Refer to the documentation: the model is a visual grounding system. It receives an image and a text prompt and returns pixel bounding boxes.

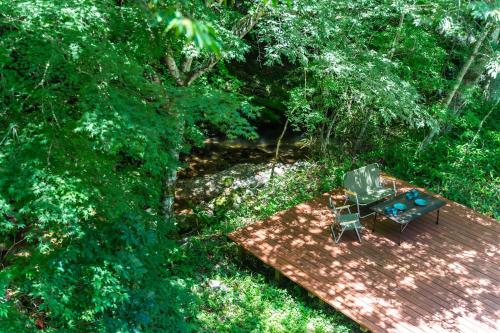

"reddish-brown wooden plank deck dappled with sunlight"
[229,178,500,333]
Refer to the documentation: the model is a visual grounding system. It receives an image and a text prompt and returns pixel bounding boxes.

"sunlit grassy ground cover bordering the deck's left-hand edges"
[170,160,360,333]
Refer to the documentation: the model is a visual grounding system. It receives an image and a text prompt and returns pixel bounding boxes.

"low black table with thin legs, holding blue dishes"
[370,191,446,245]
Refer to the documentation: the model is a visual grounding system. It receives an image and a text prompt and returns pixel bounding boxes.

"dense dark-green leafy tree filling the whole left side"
[0,0,256,332]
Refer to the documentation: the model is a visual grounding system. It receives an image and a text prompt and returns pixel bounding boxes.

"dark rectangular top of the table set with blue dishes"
[370,191,446,224]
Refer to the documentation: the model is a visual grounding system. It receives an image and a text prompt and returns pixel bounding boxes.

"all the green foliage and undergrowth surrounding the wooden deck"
[0,0,500,332]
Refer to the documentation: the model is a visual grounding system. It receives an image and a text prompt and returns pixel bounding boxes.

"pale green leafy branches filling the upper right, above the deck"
[257,0,496,153]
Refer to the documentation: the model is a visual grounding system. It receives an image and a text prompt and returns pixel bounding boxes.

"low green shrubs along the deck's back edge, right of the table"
[378,98,500,218]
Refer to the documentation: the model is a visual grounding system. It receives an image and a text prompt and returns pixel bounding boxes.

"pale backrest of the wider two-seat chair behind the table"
[344,163,380,193]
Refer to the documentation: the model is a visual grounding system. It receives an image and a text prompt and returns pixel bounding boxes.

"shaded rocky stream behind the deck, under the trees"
[174,128,307,213]
